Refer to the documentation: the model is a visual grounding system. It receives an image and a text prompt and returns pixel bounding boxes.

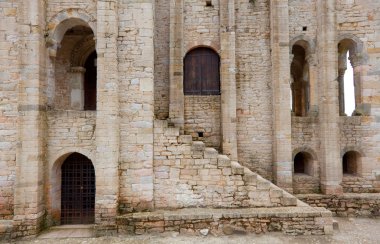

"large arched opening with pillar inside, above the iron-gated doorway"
[53,22,97,110]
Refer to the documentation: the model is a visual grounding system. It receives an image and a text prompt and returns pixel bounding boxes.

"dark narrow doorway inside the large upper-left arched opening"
[84,52,97,110]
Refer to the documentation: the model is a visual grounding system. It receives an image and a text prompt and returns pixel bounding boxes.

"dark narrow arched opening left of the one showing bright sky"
[291,44,310,116]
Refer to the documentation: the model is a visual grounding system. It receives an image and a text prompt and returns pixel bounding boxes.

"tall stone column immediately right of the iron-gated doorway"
[95,0,120,225]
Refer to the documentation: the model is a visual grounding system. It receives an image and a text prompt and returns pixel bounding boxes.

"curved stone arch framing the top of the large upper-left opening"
[46,9,96,57]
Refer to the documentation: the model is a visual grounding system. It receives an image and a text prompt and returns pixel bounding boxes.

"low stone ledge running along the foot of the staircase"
[116,207,333,235]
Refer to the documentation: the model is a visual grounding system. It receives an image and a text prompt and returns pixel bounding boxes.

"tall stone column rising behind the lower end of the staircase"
[270,0,293,192]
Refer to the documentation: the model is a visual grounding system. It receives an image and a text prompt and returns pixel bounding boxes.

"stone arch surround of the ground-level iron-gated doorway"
[49,149,97,225]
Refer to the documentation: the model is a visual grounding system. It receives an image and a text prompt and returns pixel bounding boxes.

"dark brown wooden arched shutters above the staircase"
[183,47,220,95]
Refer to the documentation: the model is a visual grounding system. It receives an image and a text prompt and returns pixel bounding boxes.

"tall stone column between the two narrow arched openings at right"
[317,0,343,194]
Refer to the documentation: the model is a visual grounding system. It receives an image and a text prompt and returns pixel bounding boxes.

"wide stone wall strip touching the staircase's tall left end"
[117,0,154,212]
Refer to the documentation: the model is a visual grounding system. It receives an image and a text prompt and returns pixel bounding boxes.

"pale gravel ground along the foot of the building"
[7,218,380,244]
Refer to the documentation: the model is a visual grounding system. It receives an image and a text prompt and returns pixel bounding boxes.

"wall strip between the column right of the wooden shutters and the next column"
[235,0,273,179]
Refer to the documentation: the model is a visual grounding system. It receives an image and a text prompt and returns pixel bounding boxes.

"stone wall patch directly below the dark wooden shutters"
[185,95,221,151]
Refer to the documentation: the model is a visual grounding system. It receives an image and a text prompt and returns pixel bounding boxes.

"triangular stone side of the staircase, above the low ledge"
[154,120,297,209]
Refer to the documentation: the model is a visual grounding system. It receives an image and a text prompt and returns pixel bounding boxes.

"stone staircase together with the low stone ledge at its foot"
[116,120,333,235]
